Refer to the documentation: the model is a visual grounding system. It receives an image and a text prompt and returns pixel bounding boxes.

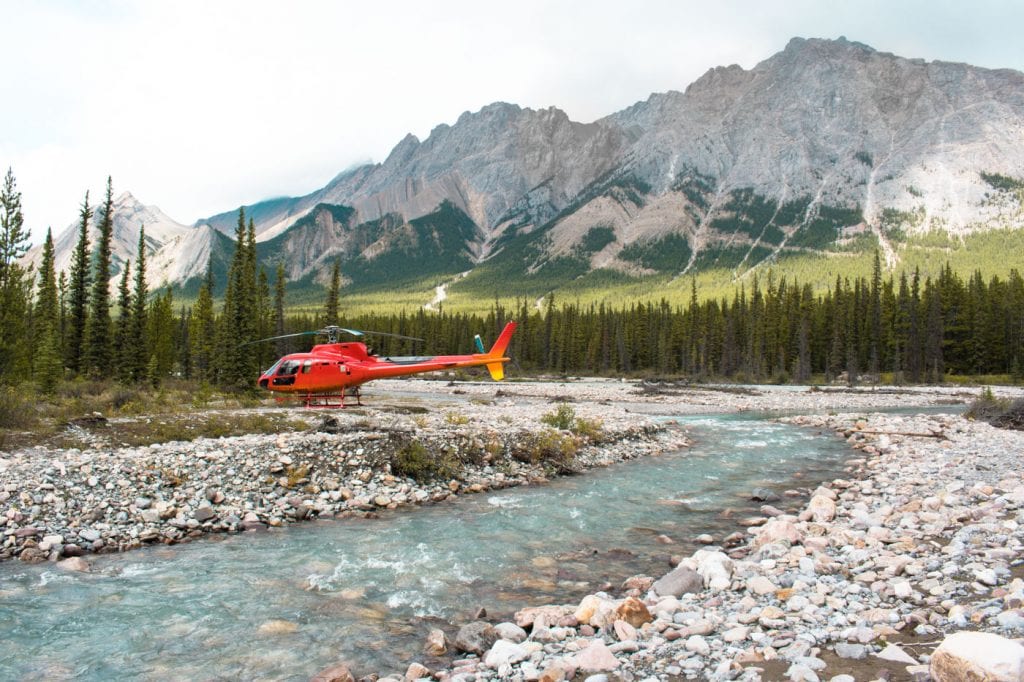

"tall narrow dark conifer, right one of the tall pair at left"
[83,176,114,376]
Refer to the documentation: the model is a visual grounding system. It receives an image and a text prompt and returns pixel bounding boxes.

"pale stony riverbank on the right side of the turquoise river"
[372,403,1024,682]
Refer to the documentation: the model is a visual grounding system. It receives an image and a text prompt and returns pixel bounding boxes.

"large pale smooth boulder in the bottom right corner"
[930,632,1024,682]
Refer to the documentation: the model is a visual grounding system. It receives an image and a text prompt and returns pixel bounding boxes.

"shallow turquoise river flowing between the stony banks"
[0,415,850,680]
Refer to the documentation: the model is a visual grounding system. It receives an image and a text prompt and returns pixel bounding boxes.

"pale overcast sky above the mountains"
[0,0,1024,242]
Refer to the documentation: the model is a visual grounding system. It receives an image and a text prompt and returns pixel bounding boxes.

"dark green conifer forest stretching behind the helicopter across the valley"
[0,170,1024,392]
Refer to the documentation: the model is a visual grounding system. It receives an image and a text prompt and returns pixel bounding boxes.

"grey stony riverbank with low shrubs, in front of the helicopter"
[0,399,683,569]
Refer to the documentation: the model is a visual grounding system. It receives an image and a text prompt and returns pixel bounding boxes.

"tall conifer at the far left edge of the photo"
[0,168,32,383]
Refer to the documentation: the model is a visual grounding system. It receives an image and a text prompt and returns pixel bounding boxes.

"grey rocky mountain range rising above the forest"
[24,38,1024,284]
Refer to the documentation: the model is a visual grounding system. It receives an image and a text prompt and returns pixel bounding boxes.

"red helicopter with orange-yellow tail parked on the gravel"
[257,322,516,408]
